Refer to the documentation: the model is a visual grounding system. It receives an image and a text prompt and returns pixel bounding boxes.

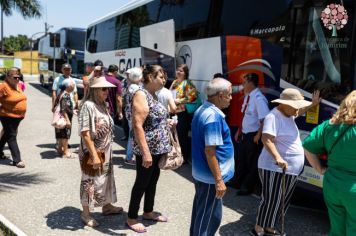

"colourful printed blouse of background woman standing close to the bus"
[172,79,198,113]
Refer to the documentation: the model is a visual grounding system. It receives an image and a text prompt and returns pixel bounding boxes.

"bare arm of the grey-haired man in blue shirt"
[205,146,226,199]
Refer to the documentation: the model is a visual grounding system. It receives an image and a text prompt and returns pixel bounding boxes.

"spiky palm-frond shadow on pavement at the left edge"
[0,171,50,192]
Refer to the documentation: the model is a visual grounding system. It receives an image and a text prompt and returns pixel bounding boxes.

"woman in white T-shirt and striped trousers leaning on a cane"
[250,88,320,235]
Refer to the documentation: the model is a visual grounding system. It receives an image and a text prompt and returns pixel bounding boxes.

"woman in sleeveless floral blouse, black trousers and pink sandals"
[126,65,171,233]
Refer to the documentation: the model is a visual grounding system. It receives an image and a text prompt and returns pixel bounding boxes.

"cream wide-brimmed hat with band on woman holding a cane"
[272,88,312,109]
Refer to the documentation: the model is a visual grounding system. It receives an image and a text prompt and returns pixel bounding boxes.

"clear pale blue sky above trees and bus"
[4,0,132,38]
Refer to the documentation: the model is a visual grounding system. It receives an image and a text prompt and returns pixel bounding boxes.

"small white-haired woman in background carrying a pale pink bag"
[52,78,75,158]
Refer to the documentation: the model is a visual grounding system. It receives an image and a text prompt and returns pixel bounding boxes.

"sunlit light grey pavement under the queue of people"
[0,81,328,236]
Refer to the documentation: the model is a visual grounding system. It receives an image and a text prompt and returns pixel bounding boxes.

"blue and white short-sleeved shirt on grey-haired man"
[192,101,235,184]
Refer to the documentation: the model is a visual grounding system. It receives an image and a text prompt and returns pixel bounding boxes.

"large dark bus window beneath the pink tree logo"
[282,4,353,104]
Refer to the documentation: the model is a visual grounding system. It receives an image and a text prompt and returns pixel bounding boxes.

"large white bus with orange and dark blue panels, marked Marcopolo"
[85,0,356,198]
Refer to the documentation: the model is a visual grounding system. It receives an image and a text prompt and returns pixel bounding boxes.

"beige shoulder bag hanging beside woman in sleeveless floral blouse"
[158,127,183,170]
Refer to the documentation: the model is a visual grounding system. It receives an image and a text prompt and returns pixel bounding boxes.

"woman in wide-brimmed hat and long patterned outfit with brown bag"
[79,76,123,227]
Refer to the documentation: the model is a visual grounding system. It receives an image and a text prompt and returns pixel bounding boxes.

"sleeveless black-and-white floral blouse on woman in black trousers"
[133,88,172,156]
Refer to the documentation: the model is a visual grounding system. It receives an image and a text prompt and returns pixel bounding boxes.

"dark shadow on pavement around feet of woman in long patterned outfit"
[46,206,127,235]
